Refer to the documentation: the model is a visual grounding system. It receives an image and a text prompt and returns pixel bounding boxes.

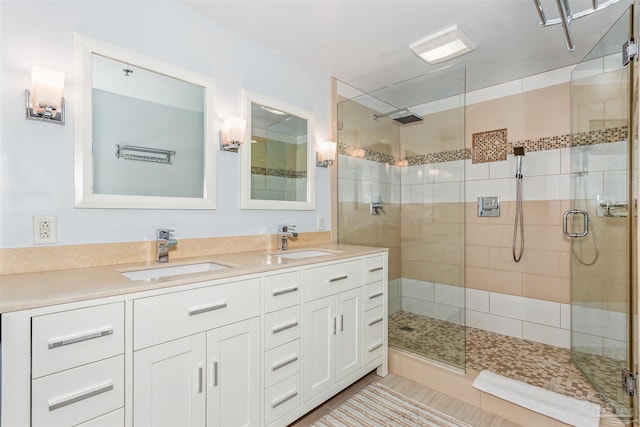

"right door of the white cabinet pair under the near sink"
[207,318,261,427]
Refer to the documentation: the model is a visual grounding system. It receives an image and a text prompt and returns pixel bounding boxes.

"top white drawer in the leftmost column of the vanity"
[31,303,124,378]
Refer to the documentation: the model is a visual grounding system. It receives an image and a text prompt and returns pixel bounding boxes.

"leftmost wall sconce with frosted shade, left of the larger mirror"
[25,67,65,125]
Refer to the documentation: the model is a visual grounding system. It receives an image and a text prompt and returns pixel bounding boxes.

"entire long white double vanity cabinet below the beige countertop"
[0,247,387,427]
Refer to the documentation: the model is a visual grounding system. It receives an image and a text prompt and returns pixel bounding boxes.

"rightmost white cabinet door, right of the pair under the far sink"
[335,288,362,381]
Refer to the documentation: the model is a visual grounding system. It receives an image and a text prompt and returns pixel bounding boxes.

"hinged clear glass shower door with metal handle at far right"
[564,5,637,422]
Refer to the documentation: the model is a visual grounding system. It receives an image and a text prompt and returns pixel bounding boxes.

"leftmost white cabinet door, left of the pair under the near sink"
[133,333,206,427]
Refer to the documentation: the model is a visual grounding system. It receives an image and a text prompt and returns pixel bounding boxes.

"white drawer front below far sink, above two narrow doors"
[304,260,362,302]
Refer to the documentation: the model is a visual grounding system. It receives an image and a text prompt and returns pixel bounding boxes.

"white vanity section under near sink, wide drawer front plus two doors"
[133,279,261,427]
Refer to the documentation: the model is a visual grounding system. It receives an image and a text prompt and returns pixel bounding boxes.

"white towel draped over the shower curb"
[473,370,600,427]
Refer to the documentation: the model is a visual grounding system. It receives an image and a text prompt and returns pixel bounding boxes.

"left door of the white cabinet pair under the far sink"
[302,297,337,401]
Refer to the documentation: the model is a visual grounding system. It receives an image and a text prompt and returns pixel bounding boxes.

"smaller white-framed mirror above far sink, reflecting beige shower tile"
[240,92,315,210]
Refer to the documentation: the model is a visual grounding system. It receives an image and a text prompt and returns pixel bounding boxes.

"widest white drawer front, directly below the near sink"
[133,279,260,350]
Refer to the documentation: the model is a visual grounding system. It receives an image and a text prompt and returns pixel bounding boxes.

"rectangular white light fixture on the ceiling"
[409,25,476,64]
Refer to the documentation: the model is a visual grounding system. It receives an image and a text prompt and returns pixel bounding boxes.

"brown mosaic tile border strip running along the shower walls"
[338,126,629,167]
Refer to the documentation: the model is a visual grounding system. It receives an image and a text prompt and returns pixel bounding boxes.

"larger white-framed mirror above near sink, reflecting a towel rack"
[74,34,217,209]
